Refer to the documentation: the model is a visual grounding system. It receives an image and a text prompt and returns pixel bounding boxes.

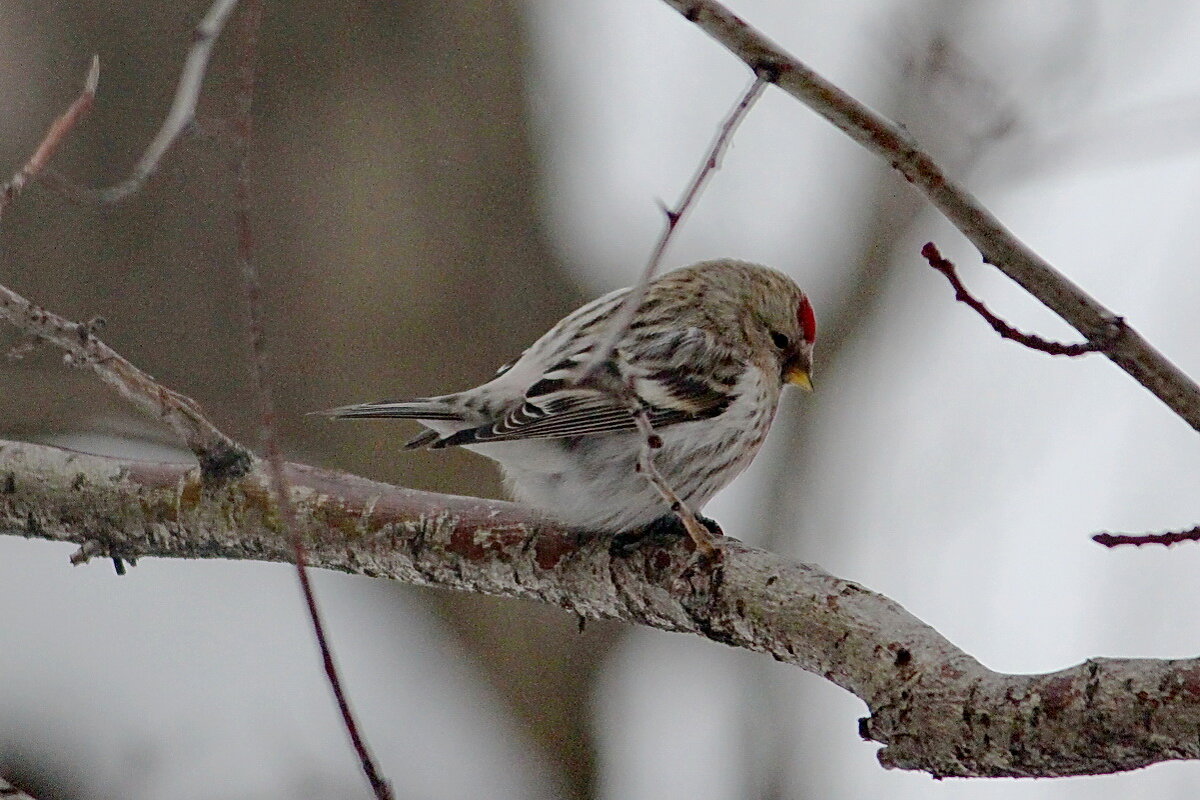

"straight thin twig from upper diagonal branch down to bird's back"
[580,74,769,380]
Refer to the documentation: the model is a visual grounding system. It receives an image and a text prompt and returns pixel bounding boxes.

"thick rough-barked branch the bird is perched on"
[0,441,1200,776]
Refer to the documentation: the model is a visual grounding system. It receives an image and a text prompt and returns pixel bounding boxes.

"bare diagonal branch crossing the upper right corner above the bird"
[664,0,1200,431]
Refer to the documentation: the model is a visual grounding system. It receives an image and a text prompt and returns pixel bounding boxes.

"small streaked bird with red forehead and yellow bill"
[326,259,816,544]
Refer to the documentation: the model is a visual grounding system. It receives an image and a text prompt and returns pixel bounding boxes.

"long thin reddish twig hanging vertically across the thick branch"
[226,0,394,800]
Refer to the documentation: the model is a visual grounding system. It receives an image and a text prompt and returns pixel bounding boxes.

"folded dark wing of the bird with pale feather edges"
[430,329,736,447]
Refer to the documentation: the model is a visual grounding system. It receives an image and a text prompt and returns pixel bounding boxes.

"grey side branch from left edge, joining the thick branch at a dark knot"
[0,285,252,480]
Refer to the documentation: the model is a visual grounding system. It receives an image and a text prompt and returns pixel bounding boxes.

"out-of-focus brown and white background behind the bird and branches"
[0,0,1200,800]
